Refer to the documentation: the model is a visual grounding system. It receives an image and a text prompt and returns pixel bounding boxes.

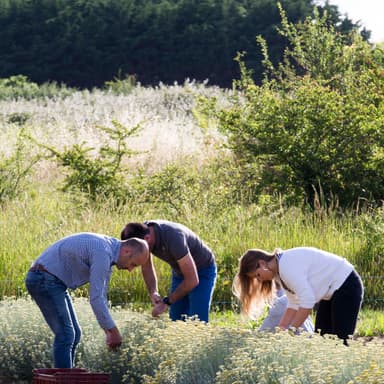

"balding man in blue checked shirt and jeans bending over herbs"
[25,232,149,368]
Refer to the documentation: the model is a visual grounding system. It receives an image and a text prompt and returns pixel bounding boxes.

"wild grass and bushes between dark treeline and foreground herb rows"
[0,5,384,305]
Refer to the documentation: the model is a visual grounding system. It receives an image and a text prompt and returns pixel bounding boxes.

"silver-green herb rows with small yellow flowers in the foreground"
[0,299,384,384]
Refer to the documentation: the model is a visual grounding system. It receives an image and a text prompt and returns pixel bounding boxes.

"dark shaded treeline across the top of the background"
[0,0,369,88]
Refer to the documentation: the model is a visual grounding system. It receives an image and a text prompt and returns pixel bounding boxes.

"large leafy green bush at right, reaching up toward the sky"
[206,4,384,207]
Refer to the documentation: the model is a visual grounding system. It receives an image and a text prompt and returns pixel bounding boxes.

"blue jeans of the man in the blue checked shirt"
[25,271,81,368]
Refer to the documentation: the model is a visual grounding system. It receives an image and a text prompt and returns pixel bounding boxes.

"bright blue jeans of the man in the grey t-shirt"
[169,265,217,322]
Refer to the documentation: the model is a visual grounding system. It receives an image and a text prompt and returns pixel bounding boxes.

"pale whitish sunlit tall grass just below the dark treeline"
[0,81,228,169]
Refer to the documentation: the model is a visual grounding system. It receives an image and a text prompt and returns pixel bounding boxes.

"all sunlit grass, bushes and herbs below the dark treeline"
[0,9,384,384]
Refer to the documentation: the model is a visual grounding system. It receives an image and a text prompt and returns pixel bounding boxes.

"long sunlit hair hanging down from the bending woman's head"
[232,249,278,319]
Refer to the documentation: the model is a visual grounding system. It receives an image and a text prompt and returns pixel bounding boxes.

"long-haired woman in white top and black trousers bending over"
[233,247,363,344]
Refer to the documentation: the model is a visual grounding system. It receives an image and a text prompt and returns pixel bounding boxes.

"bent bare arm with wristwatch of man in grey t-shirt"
[152,252,199,317]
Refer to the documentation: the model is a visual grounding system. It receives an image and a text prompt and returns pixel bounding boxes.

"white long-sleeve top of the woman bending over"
[278,247,354,309]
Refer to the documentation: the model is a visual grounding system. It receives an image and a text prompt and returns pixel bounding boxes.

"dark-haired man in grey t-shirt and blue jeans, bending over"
[121,220,217,322]
